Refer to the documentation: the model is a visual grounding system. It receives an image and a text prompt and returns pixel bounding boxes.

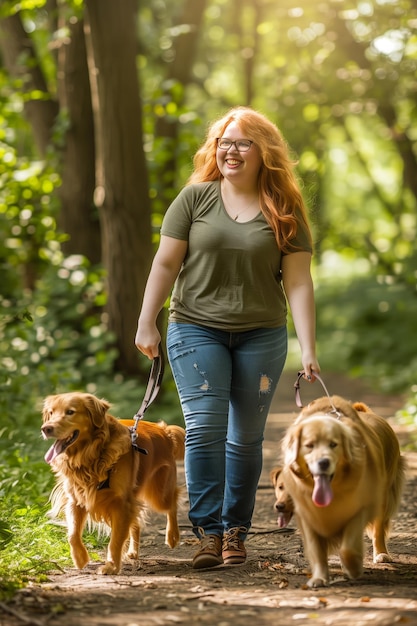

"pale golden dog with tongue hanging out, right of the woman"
[282,396,405,587]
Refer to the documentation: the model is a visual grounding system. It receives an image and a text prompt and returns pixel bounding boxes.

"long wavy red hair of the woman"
[187,107,311,252]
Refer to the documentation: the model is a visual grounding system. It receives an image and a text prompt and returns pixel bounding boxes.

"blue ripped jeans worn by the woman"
[167,322,287,539]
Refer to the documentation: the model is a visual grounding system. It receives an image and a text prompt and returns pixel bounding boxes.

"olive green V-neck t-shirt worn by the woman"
[161,181,311,332]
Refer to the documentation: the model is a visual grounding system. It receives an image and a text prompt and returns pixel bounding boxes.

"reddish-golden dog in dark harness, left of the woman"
[41,392,185,574]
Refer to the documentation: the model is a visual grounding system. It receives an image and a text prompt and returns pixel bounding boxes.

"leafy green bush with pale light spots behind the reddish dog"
[0,247,182,414]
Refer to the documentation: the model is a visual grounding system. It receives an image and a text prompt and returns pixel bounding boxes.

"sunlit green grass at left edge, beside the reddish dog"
[0,416,68,599]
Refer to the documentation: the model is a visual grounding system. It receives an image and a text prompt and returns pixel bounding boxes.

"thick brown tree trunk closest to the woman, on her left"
[85,0,153,374]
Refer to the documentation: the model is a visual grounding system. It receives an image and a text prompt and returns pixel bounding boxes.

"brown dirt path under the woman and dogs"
[0,375,417,626]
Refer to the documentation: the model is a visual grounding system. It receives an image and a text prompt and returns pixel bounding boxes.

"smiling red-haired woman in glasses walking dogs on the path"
[135,107,320,568]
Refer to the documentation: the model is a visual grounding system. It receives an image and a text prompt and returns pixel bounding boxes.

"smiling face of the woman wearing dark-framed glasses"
[216,122,262,188]
